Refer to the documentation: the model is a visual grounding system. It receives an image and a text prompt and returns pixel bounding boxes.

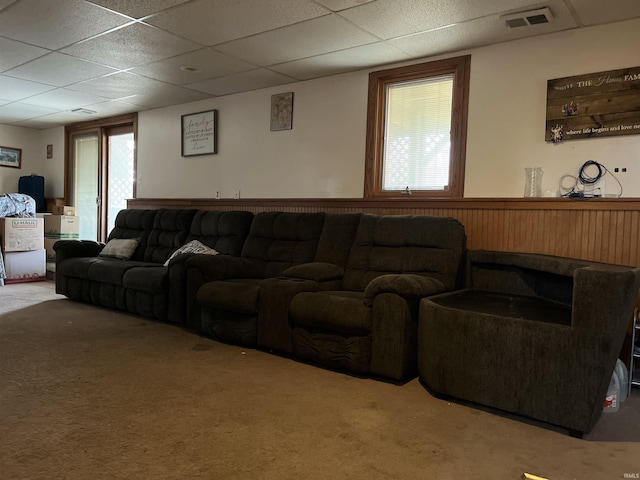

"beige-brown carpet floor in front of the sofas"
[0,282,640,480]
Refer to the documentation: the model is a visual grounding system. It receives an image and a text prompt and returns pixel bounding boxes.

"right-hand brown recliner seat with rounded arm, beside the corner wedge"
[290,214,465,381]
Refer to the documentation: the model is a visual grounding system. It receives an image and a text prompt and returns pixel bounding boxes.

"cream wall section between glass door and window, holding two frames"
[137,72,367,198]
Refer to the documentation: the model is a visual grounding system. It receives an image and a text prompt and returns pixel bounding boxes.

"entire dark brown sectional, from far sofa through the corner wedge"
[54,209,640,434]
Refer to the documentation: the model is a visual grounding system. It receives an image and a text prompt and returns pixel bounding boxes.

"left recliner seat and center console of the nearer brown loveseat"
[187,212,360,353]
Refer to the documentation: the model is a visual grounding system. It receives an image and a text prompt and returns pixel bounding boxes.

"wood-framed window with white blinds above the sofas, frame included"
[364,55,471,200]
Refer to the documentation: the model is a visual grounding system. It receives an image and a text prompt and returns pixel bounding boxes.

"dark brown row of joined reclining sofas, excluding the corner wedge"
[55,209,465,380]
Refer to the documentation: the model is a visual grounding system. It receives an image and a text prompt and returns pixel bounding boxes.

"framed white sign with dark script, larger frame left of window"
[181,110,218,157]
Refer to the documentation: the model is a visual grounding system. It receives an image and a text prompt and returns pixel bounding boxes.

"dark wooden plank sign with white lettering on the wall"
[545,67,640,143]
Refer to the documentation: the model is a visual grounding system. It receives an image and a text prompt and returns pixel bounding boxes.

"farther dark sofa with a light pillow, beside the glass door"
[54,209,253,324]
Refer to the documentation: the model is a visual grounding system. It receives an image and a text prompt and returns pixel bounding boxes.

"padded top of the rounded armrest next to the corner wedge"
[364,273,447,305]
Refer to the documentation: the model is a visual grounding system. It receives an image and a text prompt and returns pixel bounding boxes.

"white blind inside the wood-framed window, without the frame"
[382,75,454,191]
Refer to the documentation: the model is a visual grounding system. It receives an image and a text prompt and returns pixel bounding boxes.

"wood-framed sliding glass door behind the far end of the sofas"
[65,114,136,241]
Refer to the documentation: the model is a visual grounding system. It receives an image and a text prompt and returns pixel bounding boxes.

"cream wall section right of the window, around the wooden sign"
[465,19,640,197]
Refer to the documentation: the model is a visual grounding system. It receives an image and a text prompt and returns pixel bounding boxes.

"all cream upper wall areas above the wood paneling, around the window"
[5,19,640,198]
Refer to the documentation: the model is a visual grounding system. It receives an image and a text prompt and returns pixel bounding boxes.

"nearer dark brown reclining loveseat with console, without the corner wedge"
[187,213,465,380]
